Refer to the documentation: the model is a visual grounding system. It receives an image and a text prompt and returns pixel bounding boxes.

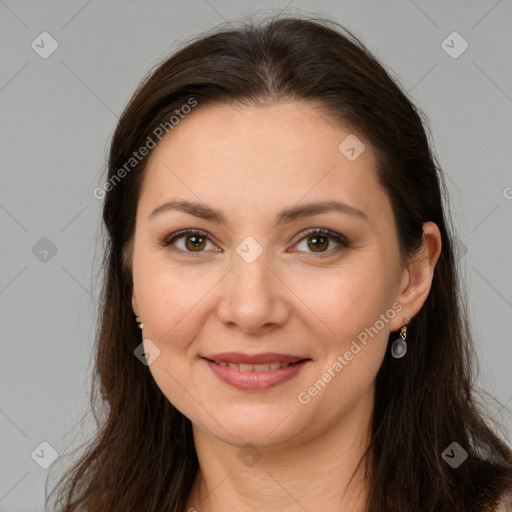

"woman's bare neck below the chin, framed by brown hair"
[185,388,373,512]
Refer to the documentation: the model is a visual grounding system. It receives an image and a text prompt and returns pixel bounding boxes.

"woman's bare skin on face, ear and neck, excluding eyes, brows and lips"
[131,101,441,512]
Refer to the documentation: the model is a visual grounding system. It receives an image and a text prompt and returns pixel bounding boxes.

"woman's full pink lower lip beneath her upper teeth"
[202,357,311,391]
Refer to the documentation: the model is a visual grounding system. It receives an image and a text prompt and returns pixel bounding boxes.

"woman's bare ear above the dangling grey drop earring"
[390,222,442,331]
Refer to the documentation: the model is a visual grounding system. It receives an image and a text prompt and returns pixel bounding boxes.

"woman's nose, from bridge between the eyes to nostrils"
[214,252,291,334]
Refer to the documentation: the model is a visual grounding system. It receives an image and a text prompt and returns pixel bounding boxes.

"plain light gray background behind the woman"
[0,0,512,512]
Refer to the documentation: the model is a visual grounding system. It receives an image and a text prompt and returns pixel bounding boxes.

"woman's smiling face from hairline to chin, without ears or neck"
[132,102,412,447]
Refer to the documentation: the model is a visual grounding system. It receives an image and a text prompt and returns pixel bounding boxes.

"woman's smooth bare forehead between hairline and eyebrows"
[141,101,387,224]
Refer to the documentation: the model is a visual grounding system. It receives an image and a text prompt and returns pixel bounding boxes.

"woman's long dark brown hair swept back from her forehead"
[47,16,512,512]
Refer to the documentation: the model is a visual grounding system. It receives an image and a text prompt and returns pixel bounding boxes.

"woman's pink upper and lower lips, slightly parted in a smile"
[202,353,311,391]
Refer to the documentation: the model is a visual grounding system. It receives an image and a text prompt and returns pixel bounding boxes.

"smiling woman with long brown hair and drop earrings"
[48,14,512,512]
